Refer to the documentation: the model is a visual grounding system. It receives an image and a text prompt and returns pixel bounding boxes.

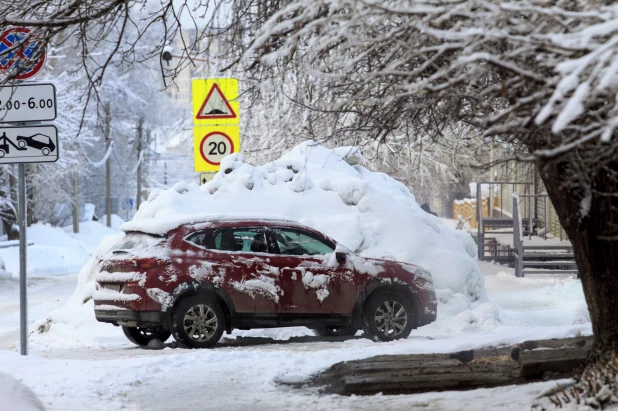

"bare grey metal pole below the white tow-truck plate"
[19,164,28,355]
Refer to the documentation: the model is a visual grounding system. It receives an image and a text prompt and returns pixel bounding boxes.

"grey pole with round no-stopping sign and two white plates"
[0,27,54,355]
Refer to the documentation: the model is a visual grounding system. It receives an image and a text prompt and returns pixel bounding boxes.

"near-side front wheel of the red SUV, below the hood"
[363,291,416,342]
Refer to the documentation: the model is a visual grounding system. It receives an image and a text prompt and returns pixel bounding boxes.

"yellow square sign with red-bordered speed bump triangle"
[191,78,240,126]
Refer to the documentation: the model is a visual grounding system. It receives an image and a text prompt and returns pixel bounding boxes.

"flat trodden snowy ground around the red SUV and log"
[0,264,591,410]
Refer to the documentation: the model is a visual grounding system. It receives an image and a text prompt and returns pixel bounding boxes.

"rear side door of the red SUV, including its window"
[183,227,281,316]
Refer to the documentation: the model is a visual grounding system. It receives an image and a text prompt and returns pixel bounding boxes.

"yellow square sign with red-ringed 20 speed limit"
[193,126,240,172]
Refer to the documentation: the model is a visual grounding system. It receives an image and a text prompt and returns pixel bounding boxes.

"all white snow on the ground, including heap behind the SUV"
[0,143,591,411]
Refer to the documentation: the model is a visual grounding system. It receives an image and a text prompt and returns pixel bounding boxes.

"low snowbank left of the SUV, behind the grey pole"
[0,221,117,278]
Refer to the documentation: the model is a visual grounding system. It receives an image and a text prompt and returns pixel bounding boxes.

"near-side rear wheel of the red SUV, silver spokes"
[171,295,225,348]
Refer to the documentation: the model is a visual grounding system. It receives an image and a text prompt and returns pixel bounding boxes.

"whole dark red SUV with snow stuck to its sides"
[93,218,437,348]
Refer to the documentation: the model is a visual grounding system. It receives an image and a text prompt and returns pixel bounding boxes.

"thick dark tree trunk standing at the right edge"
[539,153,618,355]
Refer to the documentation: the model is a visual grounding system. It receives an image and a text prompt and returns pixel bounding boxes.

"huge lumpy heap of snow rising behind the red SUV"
[121,141,486,302]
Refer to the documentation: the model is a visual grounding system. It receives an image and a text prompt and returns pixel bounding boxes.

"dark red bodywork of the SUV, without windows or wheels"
[93,219,437,331]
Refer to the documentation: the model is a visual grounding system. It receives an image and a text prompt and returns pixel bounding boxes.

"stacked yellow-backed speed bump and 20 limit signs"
[192,78,240,184]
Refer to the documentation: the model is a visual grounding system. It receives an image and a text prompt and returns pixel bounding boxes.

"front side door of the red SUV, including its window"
[268,227,356,315]
